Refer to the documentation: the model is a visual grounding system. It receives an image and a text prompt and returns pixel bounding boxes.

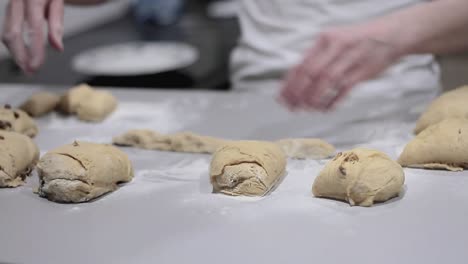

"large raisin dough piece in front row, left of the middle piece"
[37,142,133,203]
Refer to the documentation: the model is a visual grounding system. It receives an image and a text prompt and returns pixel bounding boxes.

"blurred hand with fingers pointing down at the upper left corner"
[2,0,64,73]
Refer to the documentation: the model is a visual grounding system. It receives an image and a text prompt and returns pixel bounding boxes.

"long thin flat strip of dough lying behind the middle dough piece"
[112,129,335,159]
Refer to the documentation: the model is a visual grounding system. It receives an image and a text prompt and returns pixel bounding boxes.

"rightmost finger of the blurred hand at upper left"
[47,0,63,51]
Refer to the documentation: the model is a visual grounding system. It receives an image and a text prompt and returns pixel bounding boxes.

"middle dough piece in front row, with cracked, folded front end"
[210,141,286,196]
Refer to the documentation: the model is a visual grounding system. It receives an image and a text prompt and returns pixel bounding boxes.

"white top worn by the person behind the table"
[231,0,440,101]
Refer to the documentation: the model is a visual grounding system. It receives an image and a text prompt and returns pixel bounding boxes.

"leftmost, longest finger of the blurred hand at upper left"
[2,0,28,71]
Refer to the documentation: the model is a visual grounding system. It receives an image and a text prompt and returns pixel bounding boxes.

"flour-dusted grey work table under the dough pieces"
[0,85,468,264]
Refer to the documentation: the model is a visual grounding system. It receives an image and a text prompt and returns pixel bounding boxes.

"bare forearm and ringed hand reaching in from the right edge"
[280,0,468,110]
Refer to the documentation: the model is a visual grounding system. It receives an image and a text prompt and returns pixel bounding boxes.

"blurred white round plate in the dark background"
[72,42,199,76]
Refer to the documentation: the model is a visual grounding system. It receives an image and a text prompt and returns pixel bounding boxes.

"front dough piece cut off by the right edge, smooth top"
[398,118,468,171]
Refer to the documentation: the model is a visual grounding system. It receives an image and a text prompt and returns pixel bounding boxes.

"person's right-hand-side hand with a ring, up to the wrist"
[280,26,402,111]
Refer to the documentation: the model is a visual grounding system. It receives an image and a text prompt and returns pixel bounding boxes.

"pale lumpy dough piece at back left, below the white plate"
[60,84,117,122]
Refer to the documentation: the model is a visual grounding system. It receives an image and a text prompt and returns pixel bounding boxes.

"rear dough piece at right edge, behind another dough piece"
[414,86,468,134]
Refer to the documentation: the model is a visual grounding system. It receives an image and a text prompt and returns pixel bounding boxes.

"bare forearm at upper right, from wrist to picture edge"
[375,0,468,54]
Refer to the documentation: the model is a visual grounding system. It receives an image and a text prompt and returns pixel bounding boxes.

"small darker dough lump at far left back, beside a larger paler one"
[19,92,60,117]
